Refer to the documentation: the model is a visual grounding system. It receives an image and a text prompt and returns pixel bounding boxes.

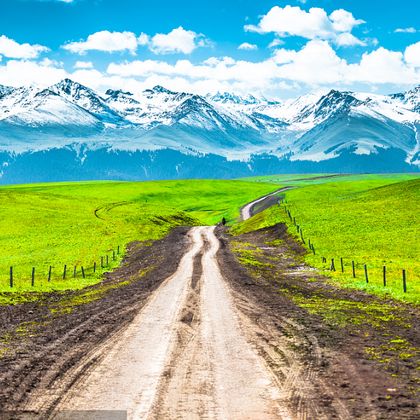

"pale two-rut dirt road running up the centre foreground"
[51,227,290,419]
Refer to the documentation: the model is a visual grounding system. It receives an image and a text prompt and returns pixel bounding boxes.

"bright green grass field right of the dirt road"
[233,174,420,303]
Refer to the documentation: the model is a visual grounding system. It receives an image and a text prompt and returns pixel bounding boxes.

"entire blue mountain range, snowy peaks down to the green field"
[0,79,420,183]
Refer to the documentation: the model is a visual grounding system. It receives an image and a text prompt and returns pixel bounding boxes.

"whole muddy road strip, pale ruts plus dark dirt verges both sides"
[0,223,420,420]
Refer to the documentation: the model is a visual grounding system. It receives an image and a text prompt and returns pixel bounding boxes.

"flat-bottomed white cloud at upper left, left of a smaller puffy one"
[63,31,138,54]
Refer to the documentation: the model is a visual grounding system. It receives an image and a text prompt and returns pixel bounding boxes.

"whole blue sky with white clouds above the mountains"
[0,0,420,98]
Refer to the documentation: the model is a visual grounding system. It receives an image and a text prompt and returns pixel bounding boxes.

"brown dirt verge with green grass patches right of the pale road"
[217,225,420,419]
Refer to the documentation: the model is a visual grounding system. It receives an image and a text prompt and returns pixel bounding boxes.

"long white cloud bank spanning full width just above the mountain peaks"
[0,39,420,96]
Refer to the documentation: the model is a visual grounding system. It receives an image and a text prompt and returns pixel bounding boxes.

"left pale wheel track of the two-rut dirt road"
[58,228,206,419]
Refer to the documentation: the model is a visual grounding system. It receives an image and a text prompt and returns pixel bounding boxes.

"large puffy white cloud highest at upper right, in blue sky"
[244,5,365,46]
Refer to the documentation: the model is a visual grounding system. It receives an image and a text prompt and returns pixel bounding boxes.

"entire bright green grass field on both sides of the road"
[0,174,420,303]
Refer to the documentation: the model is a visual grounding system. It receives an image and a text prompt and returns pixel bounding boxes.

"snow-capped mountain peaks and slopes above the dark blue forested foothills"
[0,79,420,183]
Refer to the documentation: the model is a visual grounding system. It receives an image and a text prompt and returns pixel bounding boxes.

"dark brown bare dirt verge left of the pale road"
[0,228,189,411]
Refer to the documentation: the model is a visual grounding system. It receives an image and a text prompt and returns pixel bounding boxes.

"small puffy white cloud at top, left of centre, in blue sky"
[149,26,206,54]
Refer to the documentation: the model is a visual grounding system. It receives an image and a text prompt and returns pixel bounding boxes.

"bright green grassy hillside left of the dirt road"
[0,180,276,301]
